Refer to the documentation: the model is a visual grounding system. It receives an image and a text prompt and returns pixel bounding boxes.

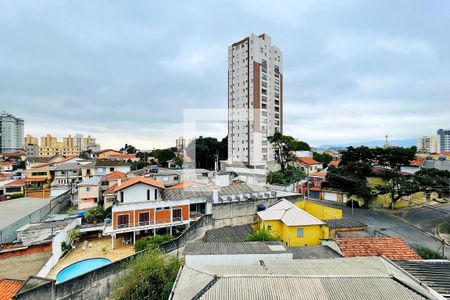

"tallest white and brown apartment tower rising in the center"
[228,34,283,166]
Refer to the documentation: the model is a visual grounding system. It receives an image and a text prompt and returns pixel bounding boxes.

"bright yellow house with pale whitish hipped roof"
[257,200,328,246]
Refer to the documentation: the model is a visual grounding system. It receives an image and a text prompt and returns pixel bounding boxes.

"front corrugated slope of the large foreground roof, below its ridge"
[199,276,426,300]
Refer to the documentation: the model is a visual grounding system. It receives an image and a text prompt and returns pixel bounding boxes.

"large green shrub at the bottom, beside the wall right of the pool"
[112,249,181,300]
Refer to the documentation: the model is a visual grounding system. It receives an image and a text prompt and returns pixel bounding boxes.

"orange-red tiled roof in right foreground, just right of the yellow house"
[336,237,421,260]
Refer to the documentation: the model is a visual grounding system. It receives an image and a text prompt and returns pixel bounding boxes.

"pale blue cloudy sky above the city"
[0,0,450,149]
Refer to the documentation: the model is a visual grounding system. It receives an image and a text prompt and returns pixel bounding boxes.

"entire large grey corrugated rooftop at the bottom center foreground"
[172,257,435,300]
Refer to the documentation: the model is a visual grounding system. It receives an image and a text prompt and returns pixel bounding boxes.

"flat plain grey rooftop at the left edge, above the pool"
[0,197,50,229]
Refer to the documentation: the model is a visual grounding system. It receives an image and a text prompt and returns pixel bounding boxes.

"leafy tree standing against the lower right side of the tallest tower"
[267,132,310,174]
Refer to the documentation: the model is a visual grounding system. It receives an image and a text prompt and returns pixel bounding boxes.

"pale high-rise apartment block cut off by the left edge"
[0,111,24,153]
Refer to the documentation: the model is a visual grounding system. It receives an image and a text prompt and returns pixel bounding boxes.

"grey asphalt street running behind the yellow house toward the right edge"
[310,200,450,256]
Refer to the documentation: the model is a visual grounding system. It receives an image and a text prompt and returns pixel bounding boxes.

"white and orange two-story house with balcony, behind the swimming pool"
[104,176,190,248]
